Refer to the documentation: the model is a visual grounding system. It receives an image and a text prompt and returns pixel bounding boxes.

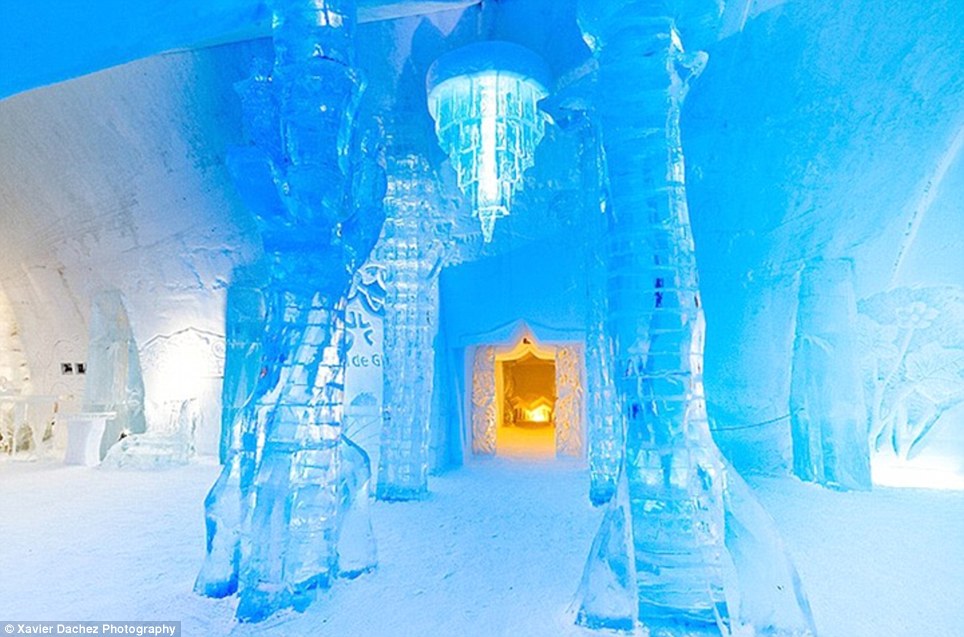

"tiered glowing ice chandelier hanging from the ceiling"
[426,41,549,242]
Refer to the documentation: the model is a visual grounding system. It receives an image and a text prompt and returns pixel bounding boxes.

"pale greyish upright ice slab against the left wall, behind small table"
[83,290,147,458]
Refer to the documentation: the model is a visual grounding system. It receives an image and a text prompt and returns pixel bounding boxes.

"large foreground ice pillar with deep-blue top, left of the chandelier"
[195,0,384,621]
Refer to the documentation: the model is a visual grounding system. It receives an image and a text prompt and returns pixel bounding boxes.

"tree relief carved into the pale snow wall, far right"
[858,286,964,459]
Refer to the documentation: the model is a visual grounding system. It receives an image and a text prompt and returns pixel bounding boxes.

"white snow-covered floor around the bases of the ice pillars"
[0,459,964,637]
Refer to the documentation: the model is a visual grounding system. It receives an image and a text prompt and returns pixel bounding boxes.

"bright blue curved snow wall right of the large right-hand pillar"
[683,0,964,471]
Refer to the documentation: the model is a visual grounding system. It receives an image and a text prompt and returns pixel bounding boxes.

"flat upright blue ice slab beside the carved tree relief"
[790,259,871,490]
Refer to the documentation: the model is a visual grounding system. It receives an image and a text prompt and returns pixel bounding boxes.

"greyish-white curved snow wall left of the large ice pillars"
[0,45,260,454]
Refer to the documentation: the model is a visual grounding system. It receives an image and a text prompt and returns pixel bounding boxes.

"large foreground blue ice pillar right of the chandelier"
[577,0,812,637]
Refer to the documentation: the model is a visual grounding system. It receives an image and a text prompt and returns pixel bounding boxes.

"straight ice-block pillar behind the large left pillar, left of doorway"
[375,144,443,500]
